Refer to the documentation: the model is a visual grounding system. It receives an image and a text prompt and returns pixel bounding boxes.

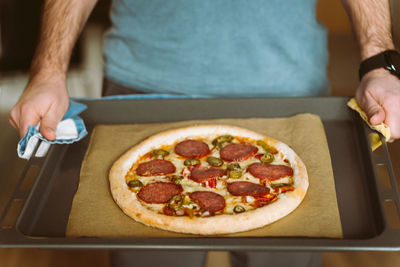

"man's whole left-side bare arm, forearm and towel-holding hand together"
[9,0,97,140]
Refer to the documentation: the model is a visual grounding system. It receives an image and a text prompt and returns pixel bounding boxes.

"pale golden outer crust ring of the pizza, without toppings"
[109,125,308,235]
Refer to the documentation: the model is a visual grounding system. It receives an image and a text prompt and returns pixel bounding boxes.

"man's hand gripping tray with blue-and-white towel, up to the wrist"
[9,76,69,140]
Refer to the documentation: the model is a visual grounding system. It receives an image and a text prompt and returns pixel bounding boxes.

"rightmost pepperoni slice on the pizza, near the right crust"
[247,162,293,180]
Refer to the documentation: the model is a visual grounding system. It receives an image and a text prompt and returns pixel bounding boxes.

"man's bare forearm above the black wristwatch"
[342,0,394,60]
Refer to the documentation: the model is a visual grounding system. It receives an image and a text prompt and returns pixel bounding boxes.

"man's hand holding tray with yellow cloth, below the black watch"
[356,69,400,141]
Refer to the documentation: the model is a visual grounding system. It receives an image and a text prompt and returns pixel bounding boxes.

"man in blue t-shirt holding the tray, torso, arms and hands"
[10,0,400,266]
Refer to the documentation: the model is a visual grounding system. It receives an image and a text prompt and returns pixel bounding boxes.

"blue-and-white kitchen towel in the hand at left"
[17,101,87,159]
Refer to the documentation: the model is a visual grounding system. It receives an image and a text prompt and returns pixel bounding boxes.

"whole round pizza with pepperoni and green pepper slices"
[109,125,308,235]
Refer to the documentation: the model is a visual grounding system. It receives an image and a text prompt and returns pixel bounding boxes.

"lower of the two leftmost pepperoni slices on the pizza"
[137,182,183,204]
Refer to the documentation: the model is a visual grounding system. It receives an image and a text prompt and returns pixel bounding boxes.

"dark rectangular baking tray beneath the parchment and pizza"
[0,97,400,251]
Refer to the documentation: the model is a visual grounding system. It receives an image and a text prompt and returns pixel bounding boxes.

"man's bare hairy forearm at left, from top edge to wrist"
[30,0,97,79]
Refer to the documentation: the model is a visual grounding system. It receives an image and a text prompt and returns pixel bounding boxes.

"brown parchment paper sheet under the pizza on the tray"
[66,114,342,238]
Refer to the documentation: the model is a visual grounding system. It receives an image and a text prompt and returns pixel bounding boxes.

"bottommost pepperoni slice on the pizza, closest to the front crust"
[190,191,225,212]
